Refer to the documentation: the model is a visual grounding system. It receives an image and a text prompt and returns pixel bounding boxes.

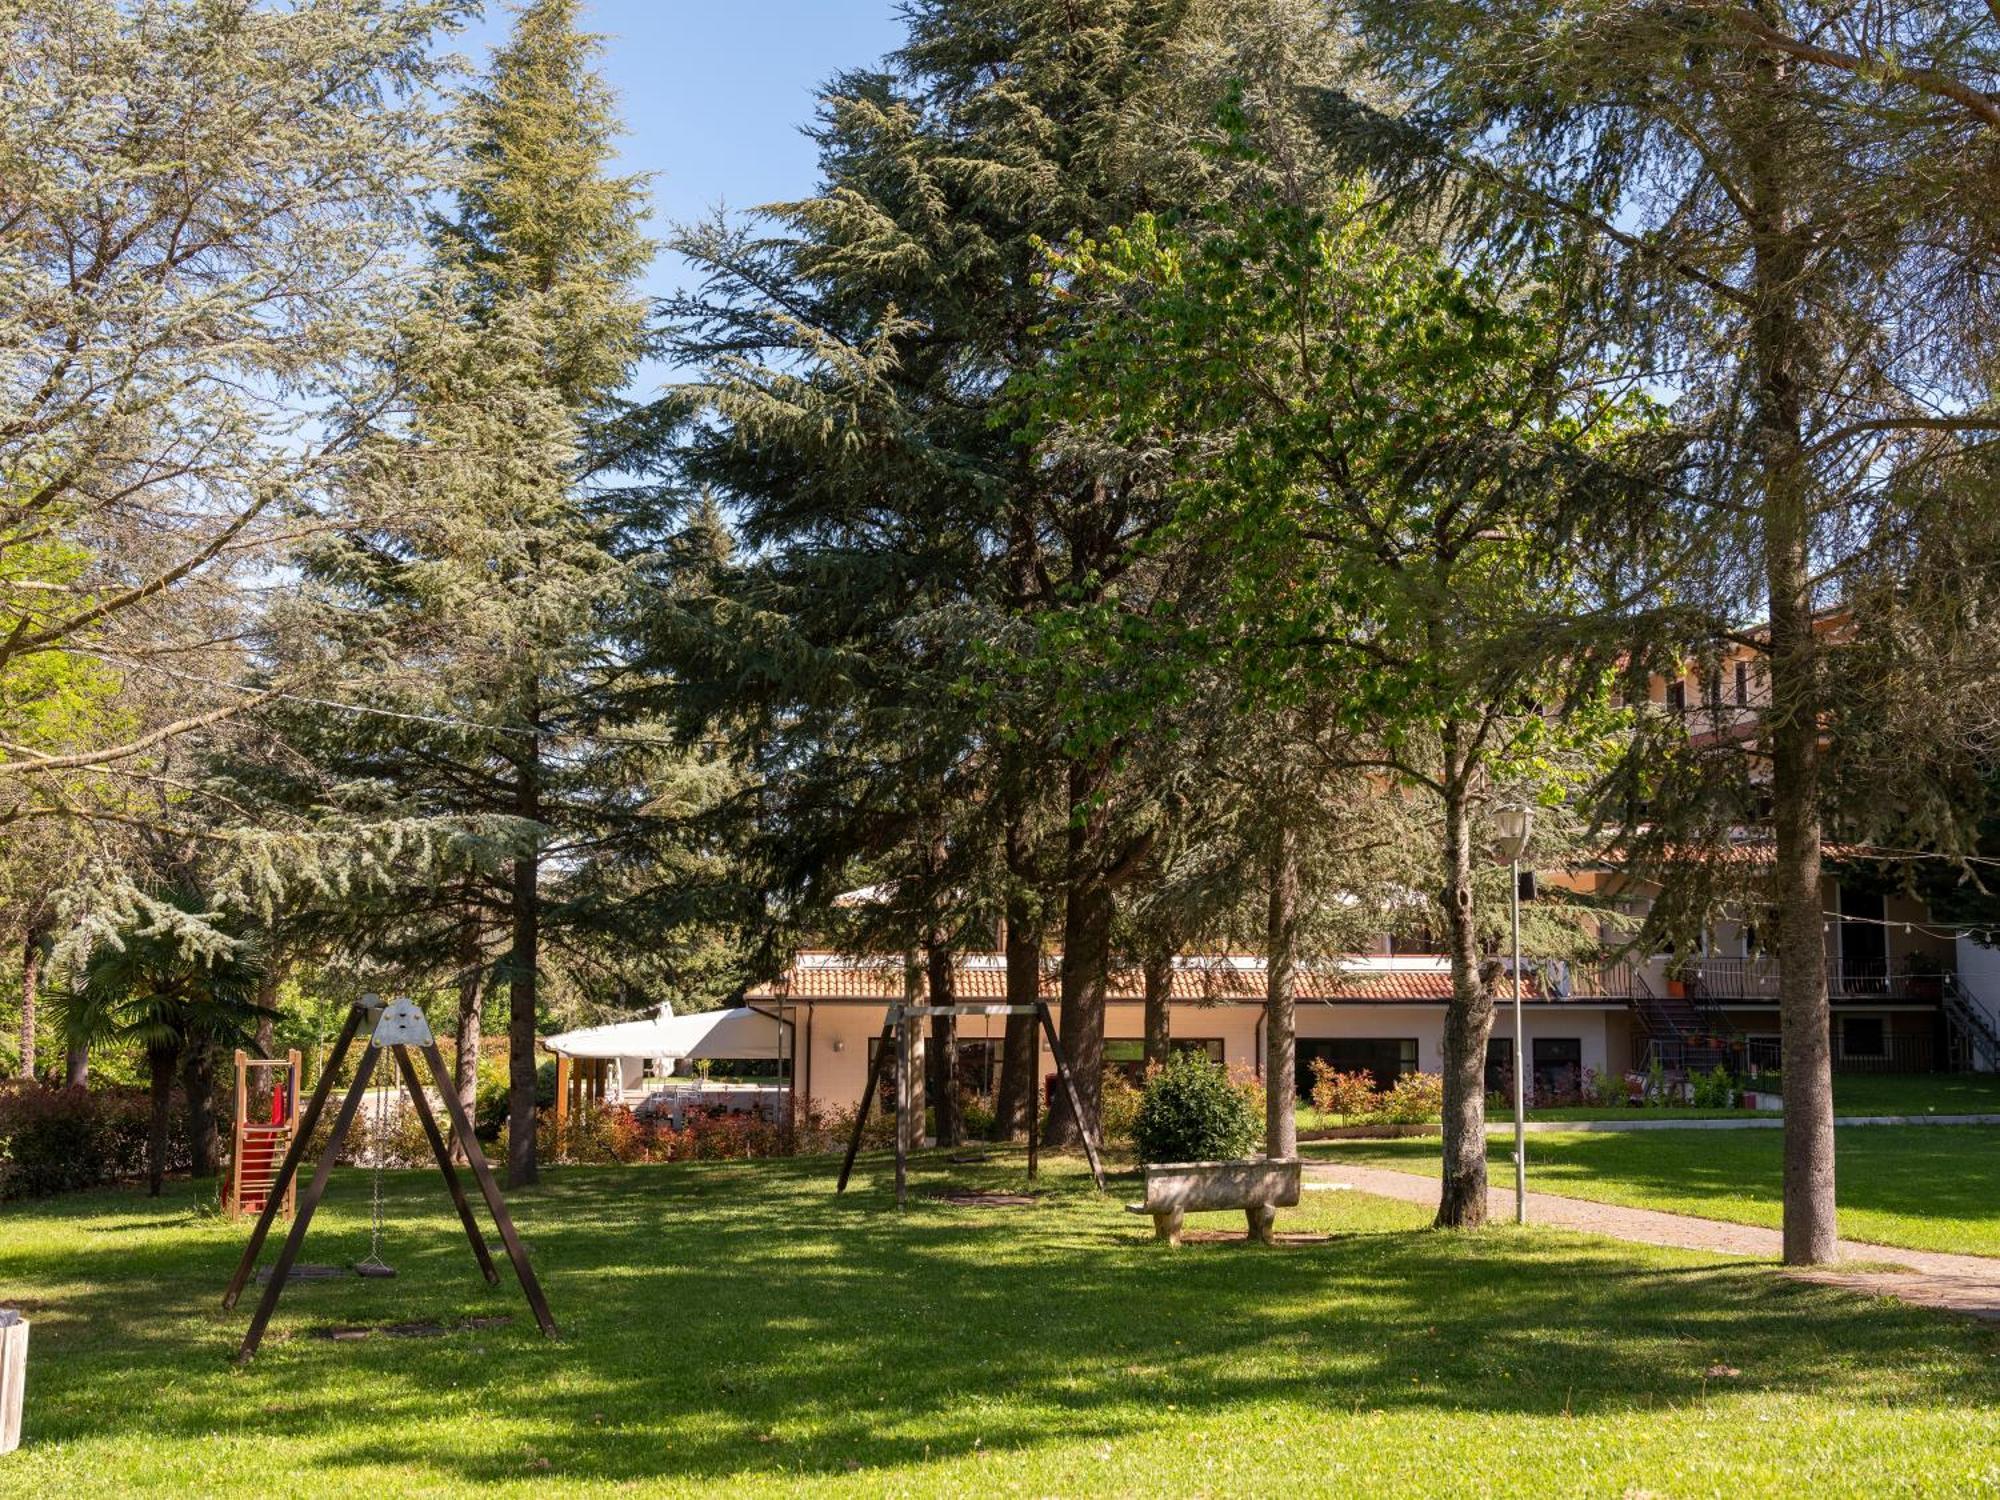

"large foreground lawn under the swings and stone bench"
[0,1160,2000,1496]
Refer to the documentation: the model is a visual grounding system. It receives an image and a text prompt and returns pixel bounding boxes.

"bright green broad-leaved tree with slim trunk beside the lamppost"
[1024,192,1676,1226]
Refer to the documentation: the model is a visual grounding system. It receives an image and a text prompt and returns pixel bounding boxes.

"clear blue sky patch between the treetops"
[458,0,902,312]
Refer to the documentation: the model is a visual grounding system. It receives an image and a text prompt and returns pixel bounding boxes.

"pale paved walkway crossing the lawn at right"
[1306,1162,2000,1322]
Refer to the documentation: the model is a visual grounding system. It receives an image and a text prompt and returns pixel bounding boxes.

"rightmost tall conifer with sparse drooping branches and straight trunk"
[1326,0,2000,1264]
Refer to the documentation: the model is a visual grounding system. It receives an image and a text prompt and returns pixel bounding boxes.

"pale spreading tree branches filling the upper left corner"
[0,0,466,848]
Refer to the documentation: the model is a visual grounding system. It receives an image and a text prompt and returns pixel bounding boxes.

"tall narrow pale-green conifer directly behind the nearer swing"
[254,0,662,1184]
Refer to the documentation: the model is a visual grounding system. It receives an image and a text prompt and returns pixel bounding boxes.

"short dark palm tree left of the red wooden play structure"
[56,888,274,1198]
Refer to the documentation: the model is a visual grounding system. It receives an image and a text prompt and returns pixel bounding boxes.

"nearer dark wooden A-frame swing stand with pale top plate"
[222,994,556,1362]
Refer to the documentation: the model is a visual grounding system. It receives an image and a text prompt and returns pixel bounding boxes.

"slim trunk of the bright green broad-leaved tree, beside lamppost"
[1436,776,1498,1230]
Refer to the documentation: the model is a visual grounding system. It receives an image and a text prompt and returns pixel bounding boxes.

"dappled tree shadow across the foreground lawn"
[0,1158,2000,1482]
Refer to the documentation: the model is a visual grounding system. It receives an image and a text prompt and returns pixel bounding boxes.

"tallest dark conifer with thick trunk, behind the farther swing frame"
[676,0,1332,1140]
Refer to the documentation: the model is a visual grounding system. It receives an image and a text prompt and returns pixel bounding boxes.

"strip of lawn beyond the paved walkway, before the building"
[1306,1126,2000,1256]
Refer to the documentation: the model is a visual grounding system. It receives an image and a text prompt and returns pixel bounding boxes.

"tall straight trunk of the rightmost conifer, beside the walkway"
[1738,26,1836,1266]
